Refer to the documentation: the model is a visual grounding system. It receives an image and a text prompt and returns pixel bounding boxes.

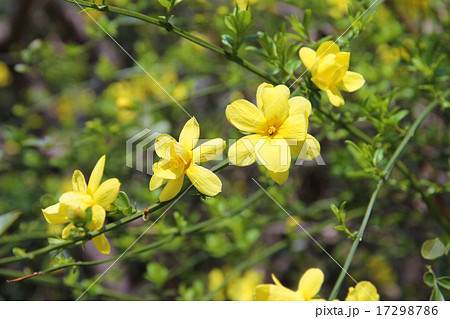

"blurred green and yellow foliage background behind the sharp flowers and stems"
[0,0,450,300]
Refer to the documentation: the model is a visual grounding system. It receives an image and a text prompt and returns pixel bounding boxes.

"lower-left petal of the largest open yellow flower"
[228,134,261,166]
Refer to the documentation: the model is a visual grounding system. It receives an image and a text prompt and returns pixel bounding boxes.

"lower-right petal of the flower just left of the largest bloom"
[186,165,222,196]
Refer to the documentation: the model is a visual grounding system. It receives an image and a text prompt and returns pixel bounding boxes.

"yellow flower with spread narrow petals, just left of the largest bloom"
[149,117,226,202]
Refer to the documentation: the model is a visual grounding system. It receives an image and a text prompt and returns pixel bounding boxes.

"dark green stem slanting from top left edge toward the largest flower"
[64,0,278,84]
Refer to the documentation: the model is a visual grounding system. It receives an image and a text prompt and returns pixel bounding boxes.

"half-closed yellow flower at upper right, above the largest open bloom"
[299,41,364,106]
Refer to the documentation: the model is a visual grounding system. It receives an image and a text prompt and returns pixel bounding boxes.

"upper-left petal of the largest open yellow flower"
[225,100,267,133]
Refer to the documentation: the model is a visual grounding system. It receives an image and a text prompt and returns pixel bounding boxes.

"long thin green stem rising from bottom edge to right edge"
[328,95,446,300]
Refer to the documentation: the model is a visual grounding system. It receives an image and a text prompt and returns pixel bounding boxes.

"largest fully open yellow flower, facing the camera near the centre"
[226,83,320,185]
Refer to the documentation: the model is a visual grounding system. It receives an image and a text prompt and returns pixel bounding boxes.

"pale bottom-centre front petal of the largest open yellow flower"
[255,138,291,173]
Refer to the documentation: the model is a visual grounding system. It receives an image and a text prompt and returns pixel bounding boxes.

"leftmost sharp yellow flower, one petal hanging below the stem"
[42,155,120,255]
